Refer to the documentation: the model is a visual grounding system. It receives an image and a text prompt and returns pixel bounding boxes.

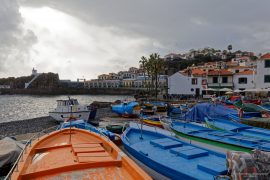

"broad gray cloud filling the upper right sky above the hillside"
[21,0,270,53]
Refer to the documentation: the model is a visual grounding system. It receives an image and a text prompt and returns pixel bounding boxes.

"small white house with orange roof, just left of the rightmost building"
[233,70,256,90]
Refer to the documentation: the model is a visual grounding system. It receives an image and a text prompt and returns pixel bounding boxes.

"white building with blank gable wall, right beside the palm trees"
[168,69,207,96]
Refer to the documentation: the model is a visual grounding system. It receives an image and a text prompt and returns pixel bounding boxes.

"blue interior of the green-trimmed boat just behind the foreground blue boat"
[171,122,270,151]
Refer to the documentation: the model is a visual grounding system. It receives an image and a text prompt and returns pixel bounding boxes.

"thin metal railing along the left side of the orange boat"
[5,125,58,180]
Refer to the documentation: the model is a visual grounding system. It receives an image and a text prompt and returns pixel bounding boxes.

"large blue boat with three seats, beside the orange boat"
[121,124,227,179]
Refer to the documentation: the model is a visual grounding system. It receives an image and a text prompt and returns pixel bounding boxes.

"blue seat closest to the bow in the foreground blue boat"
[150,138,183,149]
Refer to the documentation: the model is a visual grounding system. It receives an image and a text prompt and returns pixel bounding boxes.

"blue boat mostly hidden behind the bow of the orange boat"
[57,119,115,141]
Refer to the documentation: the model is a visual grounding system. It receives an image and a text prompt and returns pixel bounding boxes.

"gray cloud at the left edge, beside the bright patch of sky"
[0,0,37,76]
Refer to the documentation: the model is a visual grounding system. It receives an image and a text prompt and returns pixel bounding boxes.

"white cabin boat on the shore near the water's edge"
[49,98,90,122]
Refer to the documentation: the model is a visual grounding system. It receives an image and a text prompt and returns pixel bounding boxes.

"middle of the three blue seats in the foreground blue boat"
[170,146,208,159]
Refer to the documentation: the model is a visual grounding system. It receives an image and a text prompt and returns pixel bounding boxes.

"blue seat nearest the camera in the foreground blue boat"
[197,161,227,175]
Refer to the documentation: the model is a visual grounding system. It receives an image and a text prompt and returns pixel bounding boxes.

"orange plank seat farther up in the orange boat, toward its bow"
[72,143,105,155]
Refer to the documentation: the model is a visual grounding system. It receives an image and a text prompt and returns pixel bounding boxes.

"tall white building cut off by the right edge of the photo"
[255,53,270,88]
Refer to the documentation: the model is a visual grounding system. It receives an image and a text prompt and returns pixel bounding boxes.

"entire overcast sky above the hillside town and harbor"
[0,0,270,80]
